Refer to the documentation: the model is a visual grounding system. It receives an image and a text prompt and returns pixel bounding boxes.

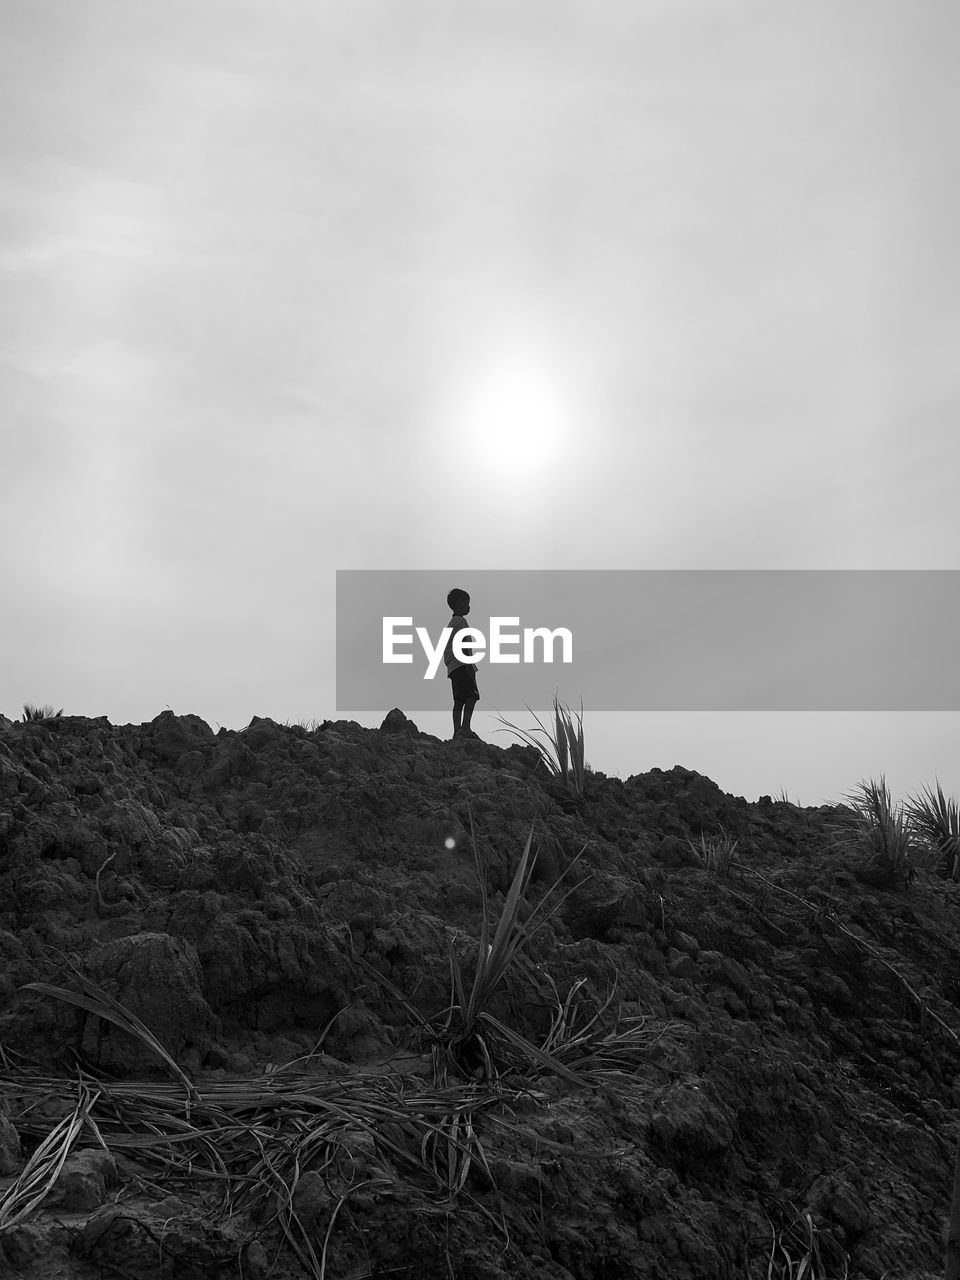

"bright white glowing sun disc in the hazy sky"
[463,358,568,479]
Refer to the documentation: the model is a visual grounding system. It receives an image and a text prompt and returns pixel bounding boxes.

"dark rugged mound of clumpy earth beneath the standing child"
[0,712,960,1280]
